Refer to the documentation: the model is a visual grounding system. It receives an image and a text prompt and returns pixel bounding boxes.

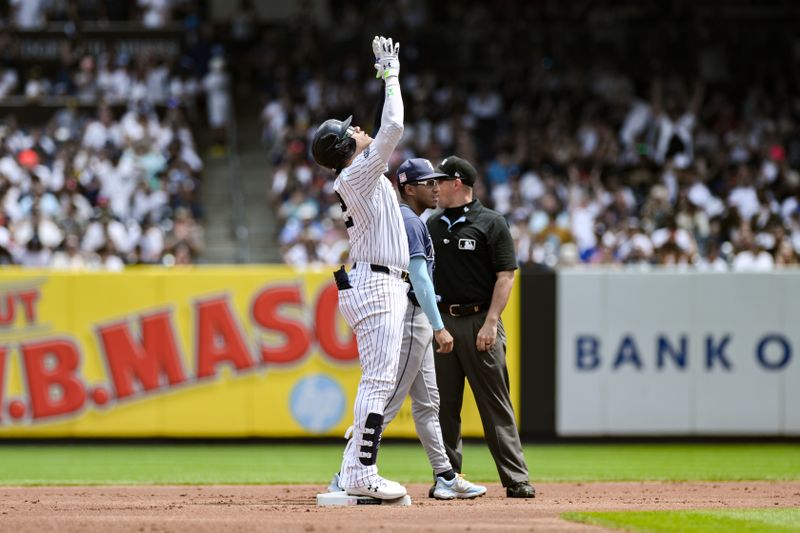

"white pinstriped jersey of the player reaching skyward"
[333,118,408,270]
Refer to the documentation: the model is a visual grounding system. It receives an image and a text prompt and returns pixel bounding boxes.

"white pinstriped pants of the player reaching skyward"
[339,265,408,489]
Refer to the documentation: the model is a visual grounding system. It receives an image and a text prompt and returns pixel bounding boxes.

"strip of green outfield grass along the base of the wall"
[0,441,800,485]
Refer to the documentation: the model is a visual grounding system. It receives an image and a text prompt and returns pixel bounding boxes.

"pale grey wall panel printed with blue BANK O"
[552,270,800,436]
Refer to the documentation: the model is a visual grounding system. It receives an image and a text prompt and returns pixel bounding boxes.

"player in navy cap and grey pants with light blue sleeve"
[328,159,486,500]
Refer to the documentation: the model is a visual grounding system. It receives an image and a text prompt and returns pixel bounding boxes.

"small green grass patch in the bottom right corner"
[561,509,800,533]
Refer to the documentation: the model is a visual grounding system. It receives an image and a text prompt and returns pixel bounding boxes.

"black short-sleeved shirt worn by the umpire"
[428,200,517,305]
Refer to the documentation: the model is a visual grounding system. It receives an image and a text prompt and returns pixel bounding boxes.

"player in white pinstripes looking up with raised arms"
[311,37,408,500]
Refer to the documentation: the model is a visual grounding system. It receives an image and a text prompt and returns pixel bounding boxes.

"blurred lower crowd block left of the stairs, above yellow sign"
[0,101,202,269]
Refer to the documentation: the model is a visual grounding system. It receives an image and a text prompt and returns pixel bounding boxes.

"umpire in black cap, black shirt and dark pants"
[428,156,536,498]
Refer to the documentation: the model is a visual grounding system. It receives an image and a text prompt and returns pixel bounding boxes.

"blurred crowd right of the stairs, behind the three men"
[262,0,800,271]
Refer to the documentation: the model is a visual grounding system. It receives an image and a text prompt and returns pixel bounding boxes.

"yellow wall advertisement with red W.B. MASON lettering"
[0,266,519,438]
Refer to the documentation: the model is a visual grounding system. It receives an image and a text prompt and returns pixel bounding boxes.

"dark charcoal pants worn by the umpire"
[434,311,528,487]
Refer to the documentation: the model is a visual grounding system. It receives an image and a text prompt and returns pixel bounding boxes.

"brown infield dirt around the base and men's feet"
[0,481,800,533]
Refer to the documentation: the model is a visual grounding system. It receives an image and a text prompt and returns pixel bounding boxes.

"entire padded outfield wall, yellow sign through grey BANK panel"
[0,266,800,438]
